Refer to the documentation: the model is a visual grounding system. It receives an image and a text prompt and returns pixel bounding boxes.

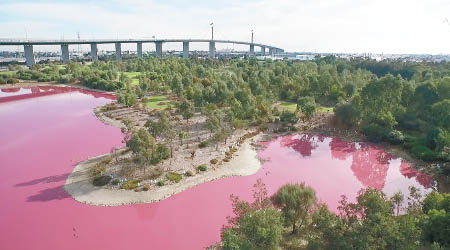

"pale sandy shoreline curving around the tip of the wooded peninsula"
[64,135,261,206]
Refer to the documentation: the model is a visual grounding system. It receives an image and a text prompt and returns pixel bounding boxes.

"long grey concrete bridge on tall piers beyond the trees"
[0,39,284,66]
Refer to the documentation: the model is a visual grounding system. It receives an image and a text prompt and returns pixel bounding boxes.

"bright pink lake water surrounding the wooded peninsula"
[0,87,432,250]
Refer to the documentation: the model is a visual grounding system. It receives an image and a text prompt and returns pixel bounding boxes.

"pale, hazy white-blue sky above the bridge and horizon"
[0,0,450,54]
